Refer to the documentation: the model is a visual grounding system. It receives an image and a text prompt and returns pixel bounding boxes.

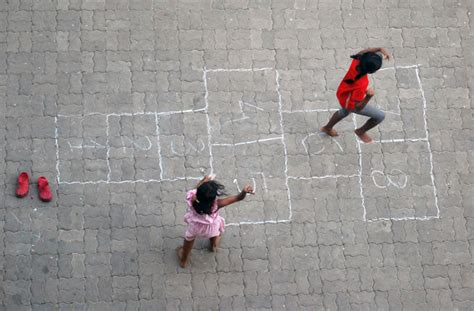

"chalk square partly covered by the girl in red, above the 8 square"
[356,67,426,141]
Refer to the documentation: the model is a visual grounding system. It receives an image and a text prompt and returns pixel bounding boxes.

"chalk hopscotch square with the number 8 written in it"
[361,142,439,221]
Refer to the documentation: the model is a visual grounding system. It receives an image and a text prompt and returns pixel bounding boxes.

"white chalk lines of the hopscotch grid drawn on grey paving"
[55,65,440,226]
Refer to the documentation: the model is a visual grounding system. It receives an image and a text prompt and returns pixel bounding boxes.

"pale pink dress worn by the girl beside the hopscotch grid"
[184,189,225,241]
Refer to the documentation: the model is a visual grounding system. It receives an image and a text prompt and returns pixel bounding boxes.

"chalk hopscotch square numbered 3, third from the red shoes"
[158,112,210,180]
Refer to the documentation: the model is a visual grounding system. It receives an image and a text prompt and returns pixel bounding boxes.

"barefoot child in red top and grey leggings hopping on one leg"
[321,48,390,143]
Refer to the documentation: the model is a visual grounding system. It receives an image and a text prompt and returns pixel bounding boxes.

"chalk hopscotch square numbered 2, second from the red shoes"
[108,113,160,182]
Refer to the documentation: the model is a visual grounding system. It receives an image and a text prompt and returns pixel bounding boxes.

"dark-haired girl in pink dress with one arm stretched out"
[178,176,253,268]
